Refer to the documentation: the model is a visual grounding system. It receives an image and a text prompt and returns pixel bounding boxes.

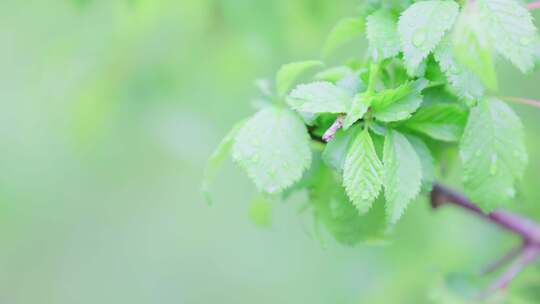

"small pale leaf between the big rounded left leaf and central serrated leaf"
[322,126,359,172]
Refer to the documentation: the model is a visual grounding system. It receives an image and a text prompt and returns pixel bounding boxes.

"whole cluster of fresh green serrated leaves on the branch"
[204,0,540,244]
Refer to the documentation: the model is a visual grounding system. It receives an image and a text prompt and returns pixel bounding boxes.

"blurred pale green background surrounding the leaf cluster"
[0,0,540,304]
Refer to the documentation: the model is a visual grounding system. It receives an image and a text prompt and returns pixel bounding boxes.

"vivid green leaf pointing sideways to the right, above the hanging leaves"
[404,103,467,142]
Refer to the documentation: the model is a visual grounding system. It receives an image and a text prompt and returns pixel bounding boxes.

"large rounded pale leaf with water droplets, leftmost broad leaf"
[232,107,311,193]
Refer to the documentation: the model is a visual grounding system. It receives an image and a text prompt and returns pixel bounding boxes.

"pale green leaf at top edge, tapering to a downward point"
[398,0,459,73]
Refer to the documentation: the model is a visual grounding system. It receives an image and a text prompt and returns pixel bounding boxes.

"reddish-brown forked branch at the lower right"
[431,184,540,297]
